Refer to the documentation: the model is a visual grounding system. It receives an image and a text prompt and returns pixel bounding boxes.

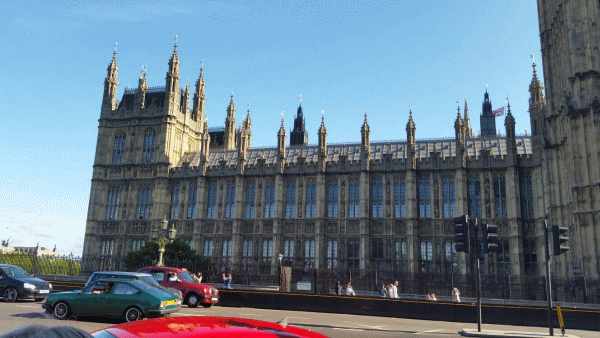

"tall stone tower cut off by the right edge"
[530,0,600,278]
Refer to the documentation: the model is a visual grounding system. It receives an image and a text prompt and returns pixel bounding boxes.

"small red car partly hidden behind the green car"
[138,266,219,308]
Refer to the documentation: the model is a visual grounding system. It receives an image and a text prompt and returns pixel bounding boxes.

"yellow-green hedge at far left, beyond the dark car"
[0,252,81,276]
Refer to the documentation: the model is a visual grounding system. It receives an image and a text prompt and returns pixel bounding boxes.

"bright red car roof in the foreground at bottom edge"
[91,316,326,338]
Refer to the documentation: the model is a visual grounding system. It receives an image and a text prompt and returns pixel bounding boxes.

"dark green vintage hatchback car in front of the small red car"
[42,278,181,322]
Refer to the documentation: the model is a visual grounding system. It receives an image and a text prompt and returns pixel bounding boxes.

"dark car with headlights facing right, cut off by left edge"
[0,264,52,302]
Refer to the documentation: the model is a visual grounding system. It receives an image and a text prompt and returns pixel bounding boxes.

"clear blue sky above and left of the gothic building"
[0,0,542,254]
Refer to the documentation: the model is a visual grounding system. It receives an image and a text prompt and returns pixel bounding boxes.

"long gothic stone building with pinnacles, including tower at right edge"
[84,0,600,278]
